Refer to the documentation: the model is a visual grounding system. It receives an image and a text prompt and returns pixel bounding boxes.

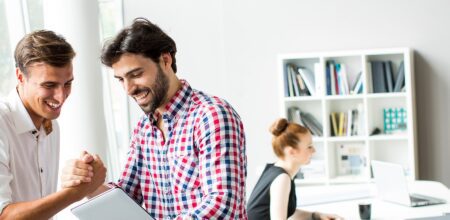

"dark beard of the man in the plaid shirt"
[134,66,169,114]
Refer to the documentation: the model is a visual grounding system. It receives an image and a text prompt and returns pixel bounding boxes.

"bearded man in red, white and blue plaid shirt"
[62,18,247,219]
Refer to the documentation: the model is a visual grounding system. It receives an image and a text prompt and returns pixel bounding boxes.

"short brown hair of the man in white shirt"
[14,30,75,74]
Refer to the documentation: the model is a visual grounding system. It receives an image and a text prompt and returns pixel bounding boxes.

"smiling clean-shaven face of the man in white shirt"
[16,62,73,128]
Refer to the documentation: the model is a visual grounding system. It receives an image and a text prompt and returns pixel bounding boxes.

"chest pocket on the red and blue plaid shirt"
[170,154,201,194]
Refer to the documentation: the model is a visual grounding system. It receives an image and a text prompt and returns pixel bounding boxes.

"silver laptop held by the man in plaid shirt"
[71,188,153,220]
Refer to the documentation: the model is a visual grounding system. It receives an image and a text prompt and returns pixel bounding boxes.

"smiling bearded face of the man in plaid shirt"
[112,53,169,114]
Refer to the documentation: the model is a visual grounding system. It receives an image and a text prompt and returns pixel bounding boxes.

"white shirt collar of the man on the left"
[8,89,53,135]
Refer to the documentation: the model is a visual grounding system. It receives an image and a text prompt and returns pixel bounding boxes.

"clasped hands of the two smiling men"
[61,151,106,199]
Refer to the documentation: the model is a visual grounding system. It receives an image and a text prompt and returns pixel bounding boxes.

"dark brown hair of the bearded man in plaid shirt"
[101,18,177,72]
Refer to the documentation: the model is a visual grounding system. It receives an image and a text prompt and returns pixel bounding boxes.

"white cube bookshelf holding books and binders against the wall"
[278,48,418,185]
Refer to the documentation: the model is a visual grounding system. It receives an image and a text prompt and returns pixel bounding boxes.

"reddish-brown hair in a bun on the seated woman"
[270,118,309,157]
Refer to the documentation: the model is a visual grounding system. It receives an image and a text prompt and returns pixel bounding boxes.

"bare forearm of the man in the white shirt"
[0,189,83,220]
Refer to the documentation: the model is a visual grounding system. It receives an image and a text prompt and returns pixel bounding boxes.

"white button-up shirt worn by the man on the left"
[0,90,60,213]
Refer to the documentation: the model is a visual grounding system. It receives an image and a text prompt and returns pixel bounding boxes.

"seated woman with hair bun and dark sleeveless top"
[247,118,341,220]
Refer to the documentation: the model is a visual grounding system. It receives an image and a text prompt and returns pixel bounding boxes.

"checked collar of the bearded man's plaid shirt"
[149,80,192,121]
